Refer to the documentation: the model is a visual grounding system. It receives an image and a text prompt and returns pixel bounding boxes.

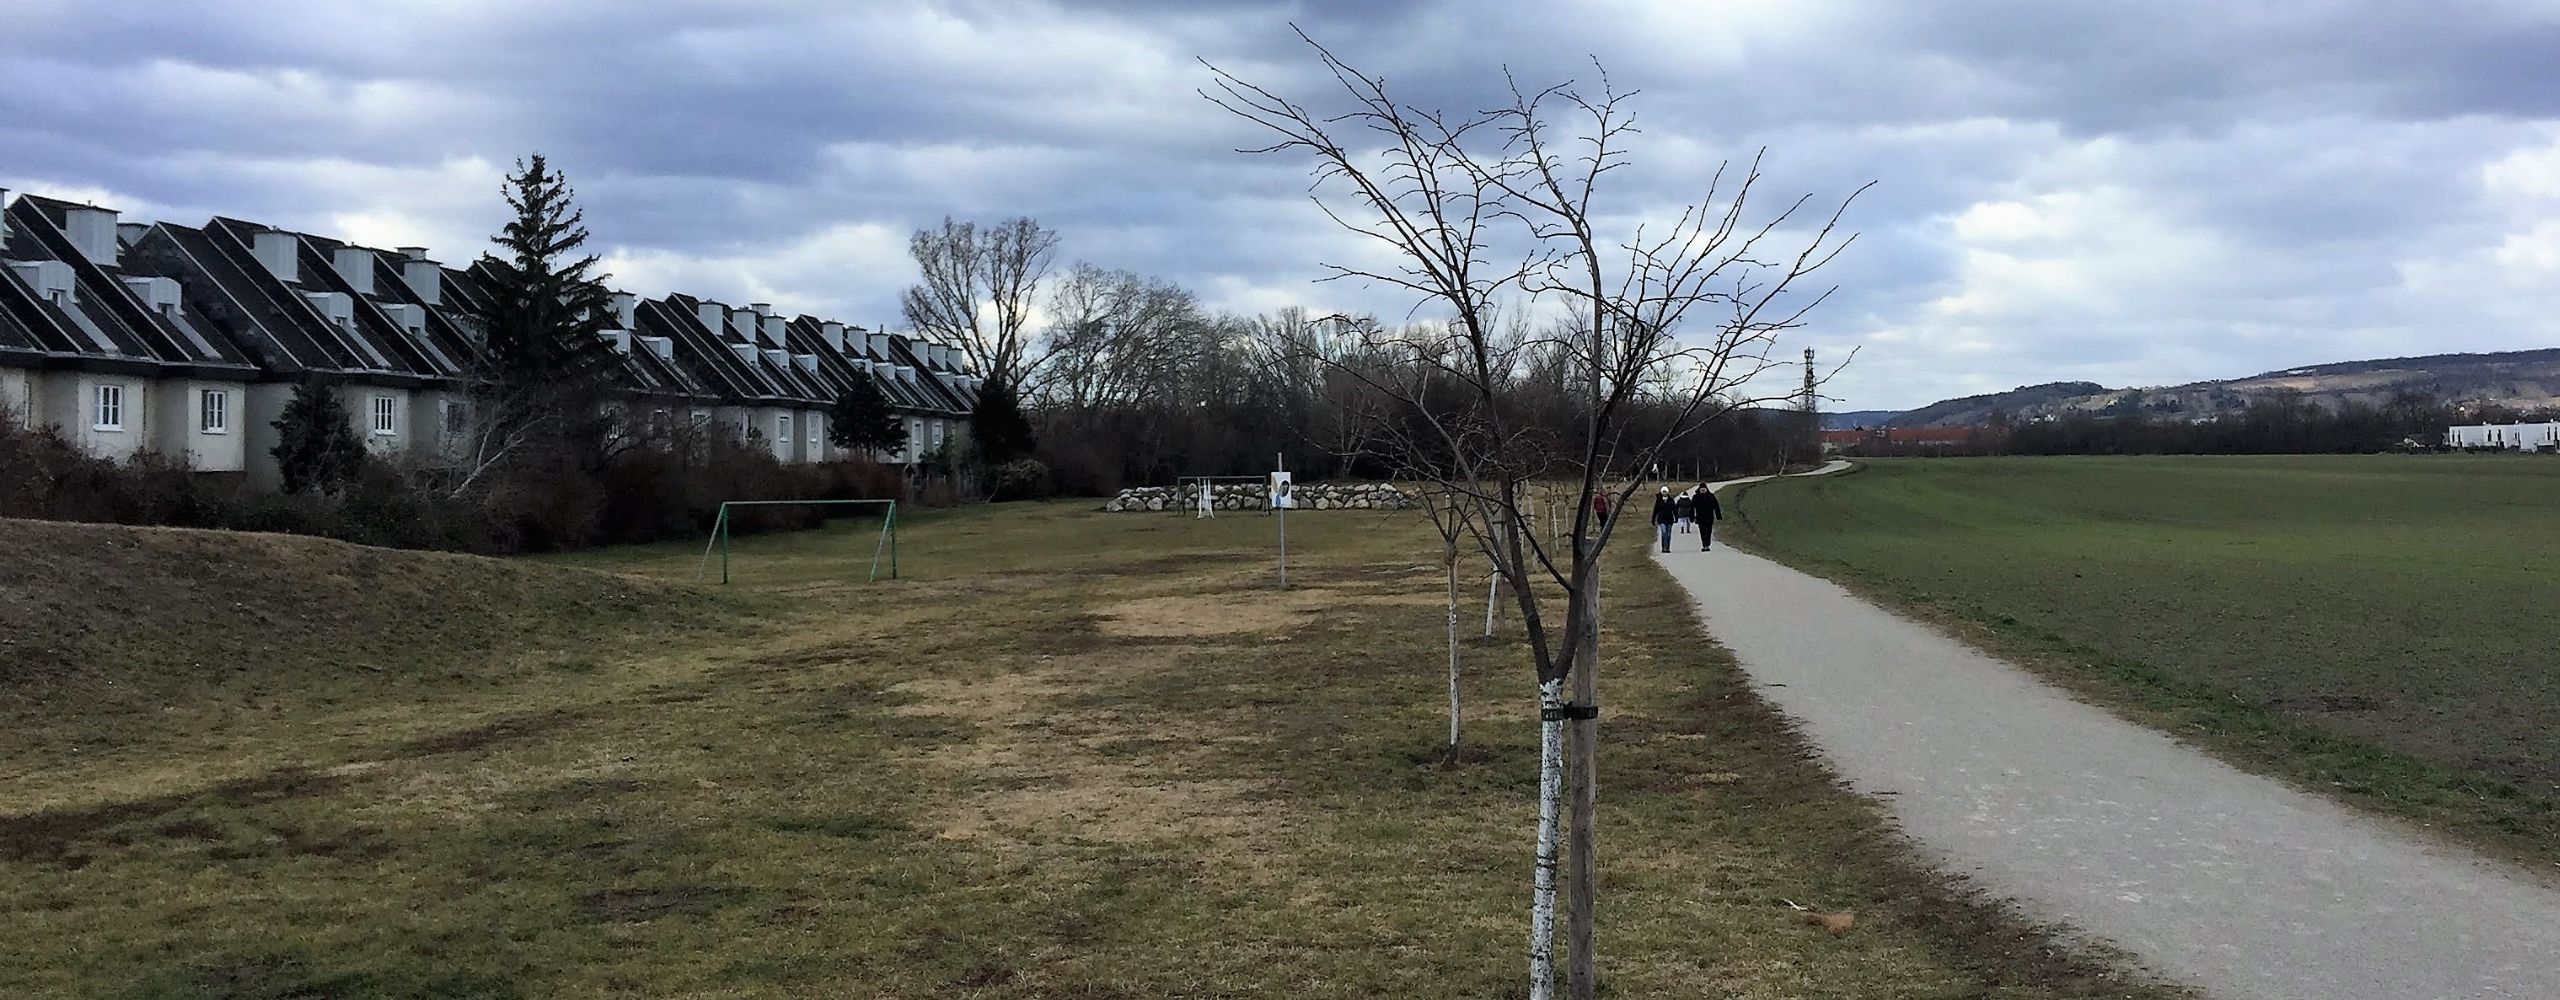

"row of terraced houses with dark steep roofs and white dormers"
[0,192,983,493]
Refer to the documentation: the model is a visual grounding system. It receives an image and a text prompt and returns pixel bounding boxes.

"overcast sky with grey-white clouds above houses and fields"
[0,0,2560,409]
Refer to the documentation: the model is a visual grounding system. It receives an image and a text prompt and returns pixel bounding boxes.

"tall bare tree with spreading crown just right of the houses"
[901,217,1057,389]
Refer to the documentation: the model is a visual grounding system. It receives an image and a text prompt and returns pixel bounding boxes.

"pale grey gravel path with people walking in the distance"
[1646,462,2560,1000]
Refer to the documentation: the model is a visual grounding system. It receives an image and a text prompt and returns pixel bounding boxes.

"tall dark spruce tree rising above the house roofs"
[481,153,620,398]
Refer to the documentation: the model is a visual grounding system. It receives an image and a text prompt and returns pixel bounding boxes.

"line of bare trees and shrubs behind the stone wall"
[904,217,1818,499]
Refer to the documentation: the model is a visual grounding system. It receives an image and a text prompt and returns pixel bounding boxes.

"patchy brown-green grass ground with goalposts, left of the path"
[0,506,2153,997]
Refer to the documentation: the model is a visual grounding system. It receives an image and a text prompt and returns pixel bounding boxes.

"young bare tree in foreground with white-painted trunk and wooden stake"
[1203,33,1864,1000]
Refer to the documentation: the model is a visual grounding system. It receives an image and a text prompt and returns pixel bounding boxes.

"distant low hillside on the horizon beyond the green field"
[1892,348,2560,427]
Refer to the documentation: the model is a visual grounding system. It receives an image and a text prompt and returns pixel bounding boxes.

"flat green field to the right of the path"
[1731,455,2560,857]
